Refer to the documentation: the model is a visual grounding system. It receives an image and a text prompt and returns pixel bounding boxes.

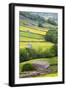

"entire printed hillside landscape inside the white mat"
[19,12,58,78]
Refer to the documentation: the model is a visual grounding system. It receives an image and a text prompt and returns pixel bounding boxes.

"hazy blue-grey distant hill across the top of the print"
[19,11,58,27]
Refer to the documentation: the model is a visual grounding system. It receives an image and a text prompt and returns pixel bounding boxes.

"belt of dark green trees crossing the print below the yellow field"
[20,45,57,62]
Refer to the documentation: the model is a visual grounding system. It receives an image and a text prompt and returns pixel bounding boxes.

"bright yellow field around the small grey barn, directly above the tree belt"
[20,41,54,50]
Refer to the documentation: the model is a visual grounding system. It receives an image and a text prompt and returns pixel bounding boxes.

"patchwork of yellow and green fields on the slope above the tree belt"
[20,26,54,50]
